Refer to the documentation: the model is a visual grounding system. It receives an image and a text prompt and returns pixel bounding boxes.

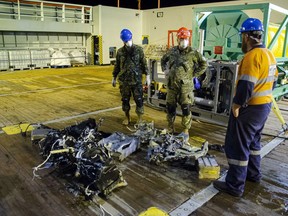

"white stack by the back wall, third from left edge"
[31,50,51,69]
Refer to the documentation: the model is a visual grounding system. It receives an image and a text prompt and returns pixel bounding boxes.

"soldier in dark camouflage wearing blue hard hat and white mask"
[112,29,150,125]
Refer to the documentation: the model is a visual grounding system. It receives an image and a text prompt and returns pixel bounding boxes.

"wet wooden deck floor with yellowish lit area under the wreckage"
[0,66,288,216]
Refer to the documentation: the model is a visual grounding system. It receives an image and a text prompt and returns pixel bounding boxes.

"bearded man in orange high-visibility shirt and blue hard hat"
[213,18,278,197]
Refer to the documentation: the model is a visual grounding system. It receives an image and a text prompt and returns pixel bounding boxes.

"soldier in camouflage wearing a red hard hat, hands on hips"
[161,27,207,140]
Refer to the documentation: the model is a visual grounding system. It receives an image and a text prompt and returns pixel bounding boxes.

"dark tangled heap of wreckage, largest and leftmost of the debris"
[33,119,127,196]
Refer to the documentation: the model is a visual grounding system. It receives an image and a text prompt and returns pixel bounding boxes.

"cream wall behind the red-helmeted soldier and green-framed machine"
[142,0,288,45]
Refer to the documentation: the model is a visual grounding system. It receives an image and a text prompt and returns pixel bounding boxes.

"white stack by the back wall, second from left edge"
[9,50,31,70]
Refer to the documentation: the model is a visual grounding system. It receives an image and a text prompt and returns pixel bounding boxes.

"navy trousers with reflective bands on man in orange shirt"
[225,103,271,193]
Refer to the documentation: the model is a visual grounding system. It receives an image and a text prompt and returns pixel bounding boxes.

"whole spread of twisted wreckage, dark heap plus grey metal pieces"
[31,118,212,197]
